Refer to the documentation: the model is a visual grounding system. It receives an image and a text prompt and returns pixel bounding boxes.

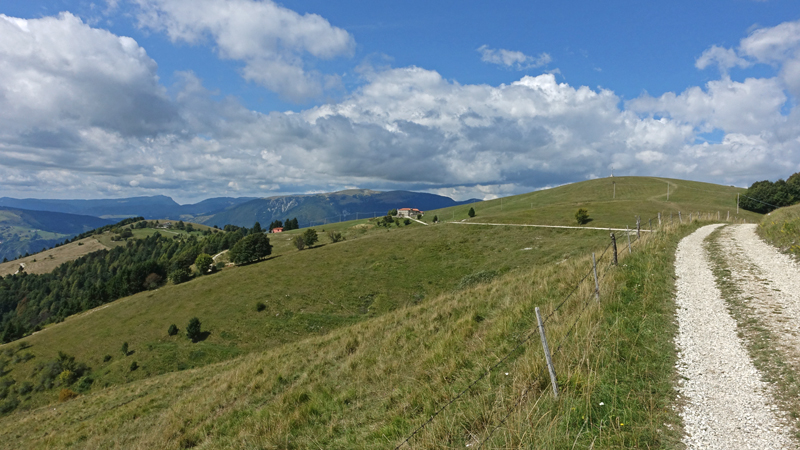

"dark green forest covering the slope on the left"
[0,221,263,342]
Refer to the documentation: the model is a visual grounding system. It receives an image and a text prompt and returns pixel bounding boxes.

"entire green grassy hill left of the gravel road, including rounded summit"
[0,178,759,448]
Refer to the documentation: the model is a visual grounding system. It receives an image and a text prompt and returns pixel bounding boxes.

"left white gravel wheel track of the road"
[675,225,795,449]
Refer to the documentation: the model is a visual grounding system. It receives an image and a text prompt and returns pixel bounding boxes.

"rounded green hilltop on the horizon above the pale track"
[424,177,761,228]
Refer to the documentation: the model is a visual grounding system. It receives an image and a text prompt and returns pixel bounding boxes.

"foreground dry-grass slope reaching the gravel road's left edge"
[0,221,696,449]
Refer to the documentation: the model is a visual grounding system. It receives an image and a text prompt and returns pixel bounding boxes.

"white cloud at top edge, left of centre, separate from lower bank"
[136,0,355,101]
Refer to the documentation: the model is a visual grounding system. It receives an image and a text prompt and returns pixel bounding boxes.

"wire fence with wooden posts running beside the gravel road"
[395,212,732,450]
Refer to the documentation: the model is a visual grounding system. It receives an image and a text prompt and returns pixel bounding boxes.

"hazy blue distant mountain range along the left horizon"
[0,189,479,258]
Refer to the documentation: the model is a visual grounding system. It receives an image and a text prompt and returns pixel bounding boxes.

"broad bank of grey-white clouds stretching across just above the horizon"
[0,14,800,200]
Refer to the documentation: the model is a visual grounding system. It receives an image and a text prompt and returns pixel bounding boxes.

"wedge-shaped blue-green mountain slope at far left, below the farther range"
[0,207,114,261]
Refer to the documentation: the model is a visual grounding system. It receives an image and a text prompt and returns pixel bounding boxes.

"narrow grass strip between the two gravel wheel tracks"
[705,225,800,438]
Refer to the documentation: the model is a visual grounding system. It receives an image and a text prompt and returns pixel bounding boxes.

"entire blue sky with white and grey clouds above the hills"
[0,0,800,203]
